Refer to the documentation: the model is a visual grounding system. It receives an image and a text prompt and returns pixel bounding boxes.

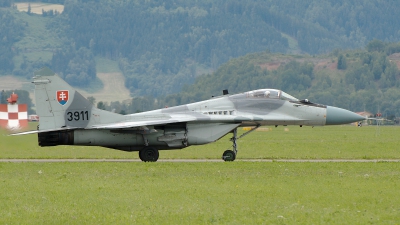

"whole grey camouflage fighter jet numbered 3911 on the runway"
[15,68,365,162]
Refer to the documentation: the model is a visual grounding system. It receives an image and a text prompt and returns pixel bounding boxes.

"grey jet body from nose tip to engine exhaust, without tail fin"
[39,89,362,151]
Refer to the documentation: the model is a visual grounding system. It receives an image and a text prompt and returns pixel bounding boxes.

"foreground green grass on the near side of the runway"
[0,162,400,224]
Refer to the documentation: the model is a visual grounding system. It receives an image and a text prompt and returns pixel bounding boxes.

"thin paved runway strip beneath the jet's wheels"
[0,159,400,163]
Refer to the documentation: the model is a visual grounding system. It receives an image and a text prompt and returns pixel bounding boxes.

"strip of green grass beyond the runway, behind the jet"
[0,123,400,159]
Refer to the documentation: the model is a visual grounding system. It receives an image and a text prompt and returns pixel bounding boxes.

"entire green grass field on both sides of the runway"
[0,123,400,224]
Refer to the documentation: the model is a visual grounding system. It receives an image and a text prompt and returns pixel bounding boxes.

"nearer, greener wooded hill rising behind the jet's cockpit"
[97,40,400,119]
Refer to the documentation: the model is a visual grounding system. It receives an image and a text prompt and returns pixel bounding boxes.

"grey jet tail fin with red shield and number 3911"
[33,67,124,130]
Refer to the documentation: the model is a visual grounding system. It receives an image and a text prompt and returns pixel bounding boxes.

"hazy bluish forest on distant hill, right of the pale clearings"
[57,0,400,97]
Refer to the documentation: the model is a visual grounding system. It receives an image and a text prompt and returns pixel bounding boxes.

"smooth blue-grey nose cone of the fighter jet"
[325,106,365,125]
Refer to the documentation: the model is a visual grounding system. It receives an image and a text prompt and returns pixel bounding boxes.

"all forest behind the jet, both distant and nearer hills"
[0,0,400,118]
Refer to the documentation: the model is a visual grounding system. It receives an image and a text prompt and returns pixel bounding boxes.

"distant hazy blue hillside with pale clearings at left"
[0,0,400,97]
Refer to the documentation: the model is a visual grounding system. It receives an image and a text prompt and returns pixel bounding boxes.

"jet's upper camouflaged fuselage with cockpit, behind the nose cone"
[128,90,327,126]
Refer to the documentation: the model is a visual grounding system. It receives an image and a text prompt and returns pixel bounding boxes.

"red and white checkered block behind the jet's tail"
[0,104,28,129]
